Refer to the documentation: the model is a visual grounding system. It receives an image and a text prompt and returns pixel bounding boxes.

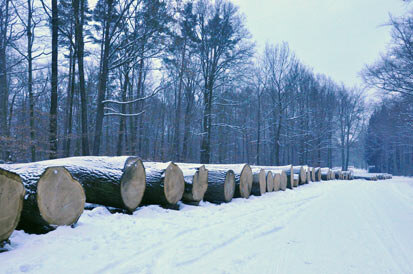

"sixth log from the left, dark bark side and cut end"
[204,165,235,204]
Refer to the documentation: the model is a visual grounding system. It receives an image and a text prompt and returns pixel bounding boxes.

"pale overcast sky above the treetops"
[232,0,408,86]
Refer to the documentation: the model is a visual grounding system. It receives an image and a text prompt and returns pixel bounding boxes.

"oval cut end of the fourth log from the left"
[164,163,185,204]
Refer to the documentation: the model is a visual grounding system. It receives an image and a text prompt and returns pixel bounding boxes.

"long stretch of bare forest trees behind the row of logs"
[0,0,366,170]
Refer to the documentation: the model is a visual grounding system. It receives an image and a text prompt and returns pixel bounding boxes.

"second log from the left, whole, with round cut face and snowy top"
[0,161,86,233]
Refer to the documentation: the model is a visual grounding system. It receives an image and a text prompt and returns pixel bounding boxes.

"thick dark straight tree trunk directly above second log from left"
[49,0,59,159]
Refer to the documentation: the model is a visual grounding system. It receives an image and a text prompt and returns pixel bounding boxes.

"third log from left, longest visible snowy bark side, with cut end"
[12,156,146,212]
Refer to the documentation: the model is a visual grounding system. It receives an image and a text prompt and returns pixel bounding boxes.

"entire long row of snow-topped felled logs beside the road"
[0,156,392,243]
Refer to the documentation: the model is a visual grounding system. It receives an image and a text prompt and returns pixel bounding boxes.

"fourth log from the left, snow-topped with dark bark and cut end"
[142,162,185,206]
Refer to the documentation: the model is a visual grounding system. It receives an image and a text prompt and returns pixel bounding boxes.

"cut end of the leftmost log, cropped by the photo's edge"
[0,170,25,242]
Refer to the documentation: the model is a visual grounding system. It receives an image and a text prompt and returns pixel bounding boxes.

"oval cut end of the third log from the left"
[120,157,146,211]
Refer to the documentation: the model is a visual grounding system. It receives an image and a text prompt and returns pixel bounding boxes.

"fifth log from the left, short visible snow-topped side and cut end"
[177,163,208,203]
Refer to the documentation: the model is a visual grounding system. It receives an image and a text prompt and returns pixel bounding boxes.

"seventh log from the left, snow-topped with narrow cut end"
[207,164,252,198]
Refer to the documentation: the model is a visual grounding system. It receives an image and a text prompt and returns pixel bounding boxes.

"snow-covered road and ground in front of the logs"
[0,177,413,274]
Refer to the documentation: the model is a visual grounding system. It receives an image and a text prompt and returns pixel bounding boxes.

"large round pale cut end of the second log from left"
[37,167,86,225]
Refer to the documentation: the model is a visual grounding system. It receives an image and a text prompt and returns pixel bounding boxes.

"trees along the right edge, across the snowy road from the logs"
[363,11,413,175]
